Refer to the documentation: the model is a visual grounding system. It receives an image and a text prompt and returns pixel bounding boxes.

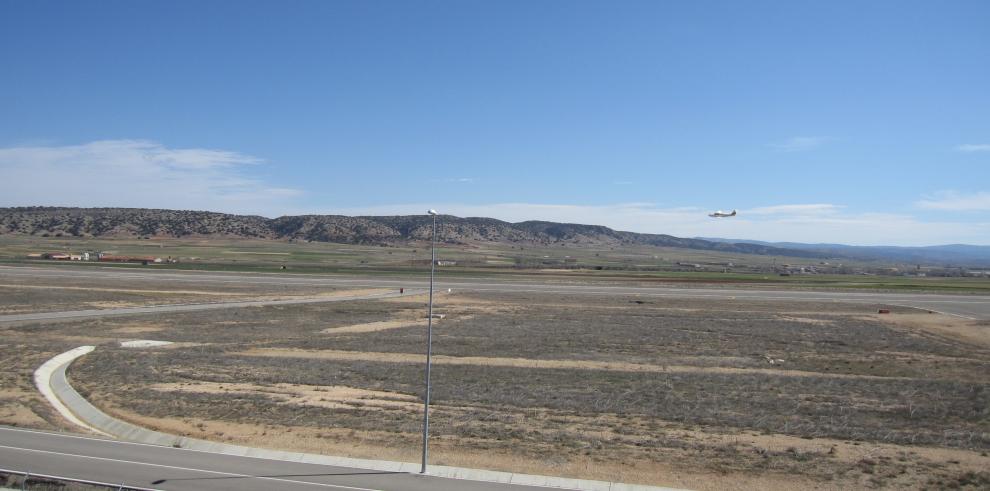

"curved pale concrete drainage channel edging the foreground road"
[35,346,688,491]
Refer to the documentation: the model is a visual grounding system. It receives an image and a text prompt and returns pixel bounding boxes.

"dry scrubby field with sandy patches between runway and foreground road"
[0,286,990,489]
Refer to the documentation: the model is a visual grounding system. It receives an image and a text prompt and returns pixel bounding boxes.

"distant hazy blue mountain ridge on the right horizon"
[699,237,990,267]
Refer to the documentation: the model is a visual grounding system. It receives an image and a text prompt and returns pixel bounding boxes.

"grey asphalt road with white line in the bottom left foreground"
[0,427,568,491]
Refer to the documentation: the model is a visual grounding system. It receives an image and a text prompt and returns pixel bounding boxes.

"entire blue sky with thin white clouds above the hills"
[0,1,990,245]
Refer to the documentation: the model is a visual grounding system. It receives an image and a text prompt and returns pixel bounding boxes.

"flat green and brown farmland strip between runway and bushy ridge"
[0,235,990,293]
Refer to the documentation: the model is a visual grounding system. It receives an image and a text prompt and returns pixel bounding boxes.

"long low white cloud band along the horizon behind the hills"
[321,203,990,246]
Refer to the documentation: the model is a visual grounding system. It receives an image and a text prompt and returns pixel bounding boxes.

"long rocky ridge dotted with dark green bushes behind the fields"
[0,207,823,257]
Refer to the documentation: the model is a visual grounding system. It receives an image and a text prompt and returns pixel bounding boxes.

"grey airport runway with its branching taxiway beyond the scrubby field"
[0,266,990,322]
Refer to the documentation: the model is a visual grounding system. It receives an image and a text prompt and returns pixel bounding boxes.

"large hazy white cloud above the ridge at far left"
[0,140,301,215]
